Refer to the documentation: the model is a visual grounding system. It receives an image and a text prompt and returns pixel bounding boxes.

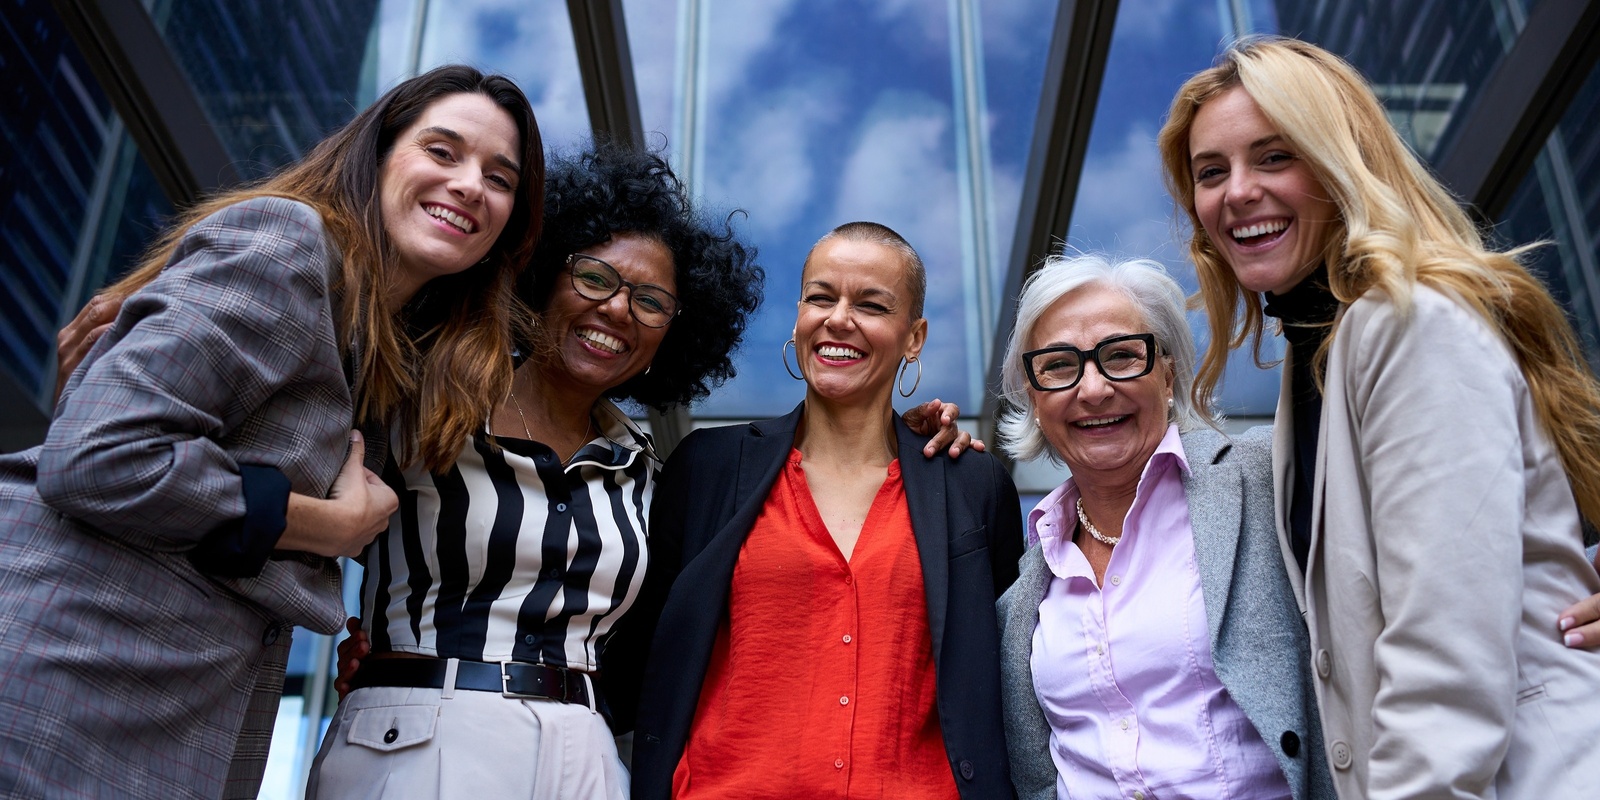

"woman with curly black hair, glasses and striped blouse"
[307,146,763,797]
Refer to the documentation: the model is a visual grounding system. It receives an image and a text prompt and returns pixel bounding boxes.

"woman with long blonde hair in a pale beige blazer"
[1160,38,1600,798]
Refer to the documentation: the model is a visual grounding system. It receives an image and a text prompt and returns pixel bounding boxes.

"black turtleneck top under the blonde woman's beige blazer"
[1262,275,1339,573]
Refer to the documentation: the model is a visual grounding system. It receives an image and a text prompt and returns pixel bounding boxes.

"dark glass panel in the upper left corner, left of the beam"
[0,0,171,414]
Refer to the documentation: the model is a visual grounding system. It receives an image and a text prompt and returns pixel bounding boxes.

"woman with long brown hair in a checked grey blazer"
[0,67,544,798]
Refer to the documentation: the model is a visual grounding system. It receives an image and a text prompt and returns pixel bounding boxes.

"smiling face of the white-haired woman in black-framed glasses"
[1027,285,1173,486]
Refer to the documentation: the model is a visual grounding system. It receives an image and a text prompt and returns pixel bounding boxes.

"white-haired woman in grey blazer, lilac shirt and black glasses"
[1000,256,1334,800]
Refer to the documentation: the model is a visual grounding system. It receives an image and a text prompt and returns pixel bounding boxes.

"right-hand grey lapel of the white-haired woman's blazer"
[1182,432,1245,653]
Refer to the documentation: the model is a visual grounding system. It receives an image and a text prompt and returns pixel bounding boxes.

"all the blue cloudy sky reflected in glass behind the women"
[371,0,1277,416]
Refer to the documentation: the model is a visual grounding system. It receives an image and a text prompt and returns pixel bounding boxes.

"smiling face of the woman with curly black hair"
[541,234,677,398]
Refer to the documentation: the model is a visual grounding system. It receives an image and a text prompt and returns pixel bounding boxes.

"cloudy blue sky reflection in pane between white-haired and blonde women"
[1067,0,1282,416]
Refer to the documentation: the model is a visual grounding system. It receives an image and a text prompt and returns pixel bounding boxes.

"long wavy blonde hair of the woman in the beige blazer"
[1158,37,1600,525]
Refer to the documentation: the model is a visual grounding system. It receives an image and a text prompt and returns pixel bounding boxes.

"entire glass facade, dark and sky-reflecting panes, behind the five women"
[0,0,1600,797]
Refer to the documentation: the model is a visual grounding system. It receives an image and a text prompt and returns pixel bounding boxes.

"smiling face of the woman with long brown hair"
[378,94,522,304]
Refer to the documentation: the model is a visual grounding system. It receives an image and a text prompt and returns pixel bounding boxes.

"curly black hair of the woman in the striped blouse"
[518,144,766,410]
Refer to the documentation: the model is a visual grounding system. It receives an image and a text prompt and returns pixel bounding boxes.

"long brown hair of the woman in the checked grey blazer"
[102,66,544,472]
